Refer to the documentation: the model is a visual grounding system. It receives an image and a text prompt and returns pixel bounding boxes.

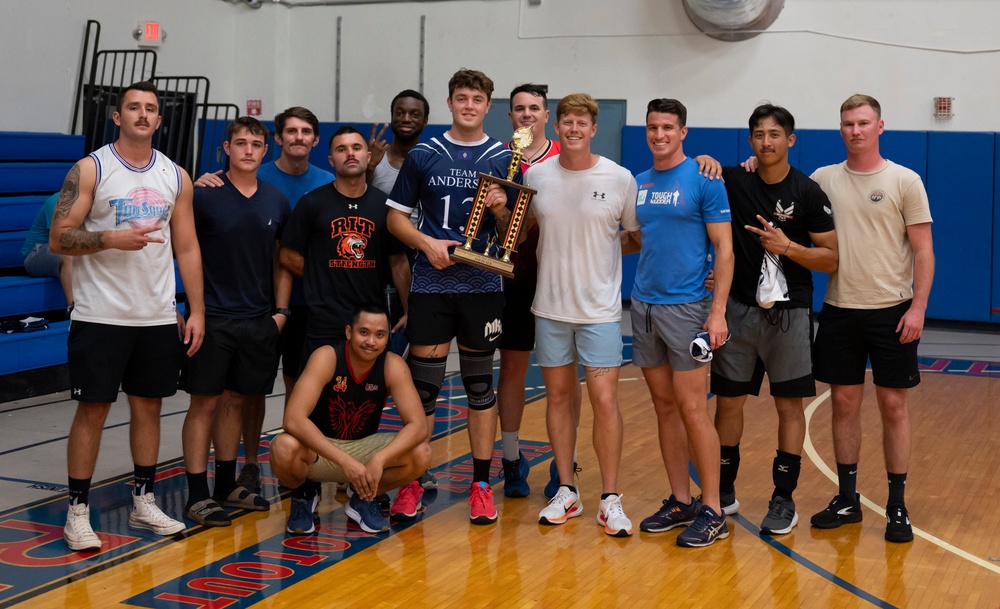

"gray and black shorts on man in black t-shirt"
[712,298,816,398]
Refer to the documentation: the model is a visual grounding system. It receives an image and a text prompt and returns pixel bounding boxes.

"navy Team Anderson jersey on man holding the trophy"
[386,133,521,294]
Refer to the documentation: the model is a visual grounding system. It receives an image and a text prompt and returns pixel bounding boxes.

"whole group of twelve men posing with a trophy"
[50,69,934,550]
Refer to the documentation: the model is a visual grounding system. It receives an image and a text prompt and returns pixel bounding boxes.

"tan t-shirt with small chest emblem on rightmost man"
[812,161,932,309]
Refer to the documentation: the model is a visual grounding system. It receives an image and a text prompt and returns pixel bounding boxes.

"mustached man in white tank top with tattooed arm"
[49,82,205,551]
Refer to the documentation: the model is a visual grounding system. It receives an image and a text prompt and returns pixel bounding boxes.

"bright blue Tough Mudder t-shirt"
[632,158,730,304]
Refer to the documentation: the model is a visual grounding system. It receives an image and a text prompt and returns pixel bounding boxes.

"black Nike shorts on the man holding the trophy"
[406,292,503,351]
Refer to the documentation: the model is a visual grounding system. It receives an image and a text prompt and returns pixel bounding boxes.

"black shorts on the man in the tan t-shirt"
[813,301,920,389]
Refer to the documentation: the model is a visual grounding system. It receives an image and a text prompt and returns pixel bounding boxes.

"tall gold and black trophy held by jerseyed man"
[451,127,538,277]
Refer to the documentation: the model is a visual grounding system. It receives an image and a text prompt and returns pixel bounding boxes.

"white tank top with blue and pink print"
[72,144,181,326]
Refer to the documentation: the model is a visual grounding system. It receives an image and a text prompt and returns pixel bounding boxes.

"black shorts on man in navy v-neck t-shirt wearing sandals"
[181,315,278,395]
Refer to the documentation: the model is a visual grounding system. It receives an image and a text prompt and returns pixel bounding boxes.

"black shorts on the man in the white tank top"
[68,321,184,404]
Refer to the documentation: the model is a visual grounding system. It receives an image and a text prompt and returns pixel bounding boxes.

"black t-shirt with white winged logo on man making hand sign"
[722,167,833,308]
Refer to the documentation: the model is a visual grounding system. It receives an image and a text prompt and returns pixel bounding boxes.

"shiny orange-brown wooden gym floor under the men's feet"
[0,358,1000,609]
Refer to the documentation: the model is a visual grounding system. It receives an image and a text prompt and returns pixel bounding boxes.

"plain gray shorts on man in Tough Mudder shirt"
[631,297,712,372]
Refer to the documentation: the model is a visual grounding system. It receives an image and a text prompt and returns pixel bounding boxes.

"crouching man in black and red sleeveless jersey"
[271,303,431,535]
